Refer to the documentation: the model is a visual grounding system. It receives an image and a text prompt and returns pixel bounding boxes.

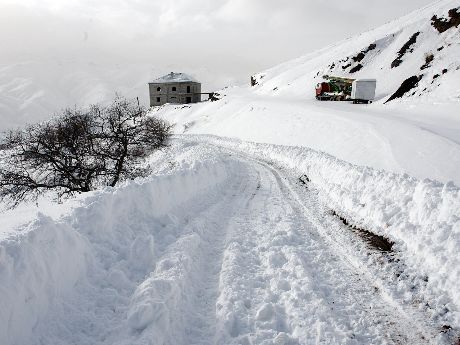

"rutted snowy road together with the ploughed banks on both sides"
[0,136,460,344]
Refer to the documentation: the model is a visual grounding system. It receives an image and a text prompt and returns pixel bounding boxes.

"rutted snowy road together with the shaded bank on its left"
[0,137,456,345]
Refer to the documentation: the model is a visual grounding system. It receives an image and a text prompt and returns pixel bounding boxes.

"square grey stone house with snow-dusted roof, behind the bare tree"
[149,72,201,107]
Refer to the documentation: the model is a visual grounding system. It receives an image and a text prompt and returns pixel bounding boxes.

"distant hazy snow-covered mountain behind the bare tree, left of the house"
[0,60,155,130]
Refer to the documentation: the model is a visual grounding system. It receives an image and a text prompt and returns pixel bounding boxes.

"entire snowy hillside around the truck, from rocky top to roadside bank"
[157,0,460,184]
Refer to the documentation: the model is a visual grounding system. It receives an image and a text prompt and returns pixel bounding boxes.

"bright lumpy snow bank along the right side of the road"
[198,137,460,321]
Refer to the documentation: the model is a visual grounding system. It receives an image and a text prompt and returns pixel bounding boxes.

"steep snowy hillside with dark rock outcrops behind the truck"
[255,0,460,103]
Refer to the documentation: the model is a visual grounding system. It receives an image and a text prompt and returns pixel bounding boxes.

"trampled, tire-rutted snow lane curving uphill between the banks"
[212,149,431,344]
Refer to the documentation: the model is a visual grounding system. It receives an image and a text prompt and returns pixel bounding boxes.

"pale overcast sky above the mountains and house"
[0,0,432,88]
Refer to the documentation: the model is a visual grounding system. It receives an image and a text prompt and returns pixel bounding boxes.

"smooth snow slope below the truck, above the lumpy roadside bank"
[157,88,460,185]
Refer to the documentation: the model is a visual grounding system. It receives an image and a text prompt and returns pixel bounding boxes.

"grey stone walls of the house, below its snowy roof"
[149,82,201,107]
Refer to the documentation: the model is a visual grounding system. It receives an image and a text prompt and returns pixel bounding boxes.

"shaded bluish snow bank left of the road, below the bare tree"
[0,155,237,345]
